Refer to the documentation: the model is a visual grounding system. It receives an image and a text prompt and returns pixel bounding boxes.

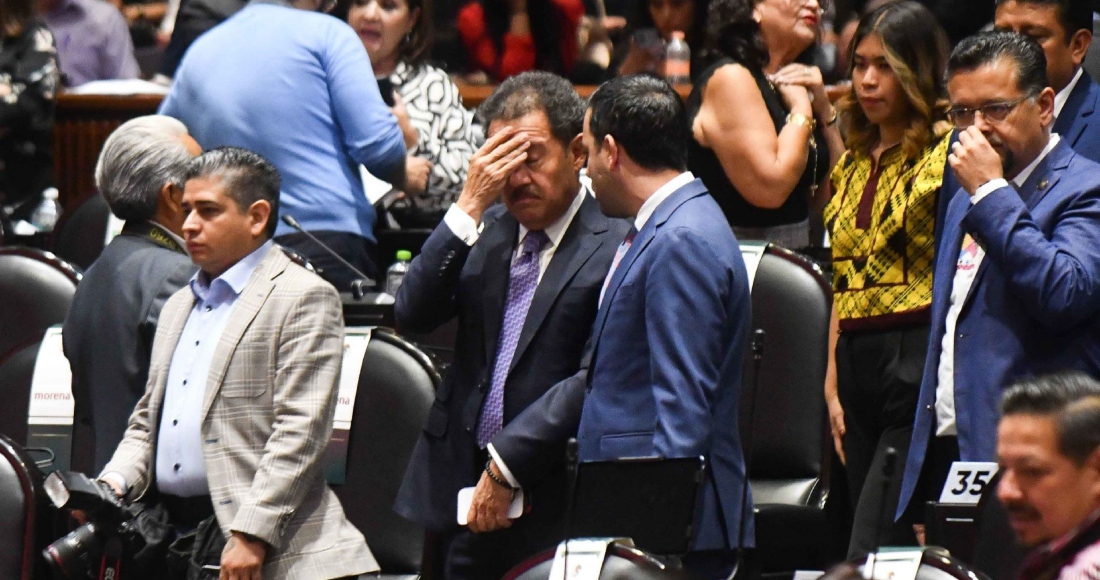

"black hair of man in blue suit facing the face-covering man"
[589,75,692,171]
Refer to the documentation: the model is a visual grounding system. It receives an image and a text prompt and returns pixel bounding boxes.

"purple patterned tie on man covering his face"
[477,230,550,449]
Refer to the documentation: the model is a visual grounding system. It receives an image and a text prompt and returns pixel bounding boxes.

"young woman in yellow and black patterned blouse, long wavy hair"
[825,0,950,557]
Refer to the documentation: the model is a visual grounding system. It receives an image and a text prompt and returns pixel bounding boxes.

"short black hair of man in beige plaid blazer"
[186,147,282,238]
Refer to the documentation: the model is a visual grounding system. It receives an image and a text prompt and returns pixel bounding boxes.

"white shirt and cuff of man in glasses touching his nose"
[936,133,1059,437]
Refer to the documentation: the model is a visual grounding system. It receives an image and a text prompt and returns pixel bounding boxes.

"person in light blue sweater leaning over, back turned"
[161,0,406,291]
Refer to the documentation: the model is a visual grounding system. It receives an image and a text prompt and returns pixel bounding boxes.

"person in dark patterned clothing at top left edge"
[0,0,61,219]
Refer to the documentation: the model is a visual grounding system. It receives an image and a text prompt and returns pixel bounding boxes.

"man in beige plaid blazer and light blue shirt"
[101,147,378,580]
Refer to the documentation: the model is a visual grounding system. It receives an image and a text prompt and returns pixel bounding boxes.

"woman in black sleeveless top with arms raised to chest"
[688,0,844,248]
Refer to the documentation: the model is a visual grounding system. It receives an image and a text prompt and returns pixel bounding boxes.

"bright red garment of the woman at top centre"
[457,0,584,80]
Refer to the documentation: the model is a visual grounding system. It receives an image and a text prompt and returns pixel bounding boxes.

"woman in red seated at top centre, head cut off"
[458,0,584,81]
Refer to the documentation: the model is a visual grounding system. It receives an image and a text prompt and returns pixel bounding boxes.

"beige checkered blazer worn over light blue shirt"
[103,248,378,580]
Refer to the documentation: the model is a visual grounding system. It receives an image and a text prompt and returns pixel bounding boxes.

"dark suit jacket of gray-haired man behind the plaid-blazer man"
[63,221,196,473]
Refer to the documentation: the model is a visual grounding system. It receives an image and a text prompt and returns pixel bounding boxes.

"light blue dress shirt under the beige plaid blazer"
[156,240,273,497]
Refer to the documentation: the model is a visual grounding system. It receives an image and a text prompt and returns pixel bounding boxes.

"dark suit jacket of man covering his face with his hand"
[395,194,628,534]
